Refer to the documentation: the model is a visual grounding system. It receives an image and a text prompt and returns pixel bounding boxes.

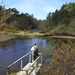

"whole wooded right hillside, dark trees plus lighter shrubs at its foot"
[43,3,75,36]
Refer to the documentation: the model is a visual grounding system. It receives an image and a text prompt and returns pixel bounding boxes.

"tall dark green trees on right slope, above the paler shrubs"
[46,3,75,28]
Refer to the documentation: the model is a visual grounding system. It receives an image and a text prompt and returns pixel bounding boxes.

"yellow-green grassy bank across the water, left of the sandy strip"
[0,30,45,42]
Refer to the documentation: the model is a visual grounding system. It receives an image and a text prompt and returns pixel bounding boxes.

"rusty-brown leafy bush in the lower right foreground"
[41,41,75,75]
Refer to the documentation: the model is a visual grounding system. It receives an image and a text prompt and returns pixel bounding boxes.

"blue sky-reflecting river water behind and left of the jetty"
[0,38,48,75]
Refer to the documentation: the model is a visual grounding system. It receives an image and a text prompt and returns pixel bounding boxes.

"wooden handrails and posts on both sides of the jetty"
[7,52,42,75]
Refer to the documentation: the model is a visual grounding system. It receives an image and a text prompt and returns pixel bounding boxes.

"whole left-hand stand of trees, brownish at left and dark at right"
[0,6,38,30]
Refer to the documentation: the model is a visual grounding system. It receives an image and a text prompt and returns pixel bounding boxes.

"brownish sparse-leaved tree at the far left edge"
[0,5,11,29]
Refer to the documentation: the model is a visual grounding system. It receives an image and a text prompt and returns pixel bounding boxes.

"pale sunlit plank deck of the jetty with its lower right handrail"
[17,56,42,75]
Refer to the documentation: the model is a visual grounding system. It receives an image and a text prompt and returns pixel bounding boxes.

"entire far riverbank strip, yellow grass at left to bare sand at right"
[0,31,75,42]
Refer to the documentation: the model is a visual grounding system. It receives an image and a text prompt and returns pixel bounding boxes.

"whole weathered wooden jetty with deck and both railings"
[7,52,42,75]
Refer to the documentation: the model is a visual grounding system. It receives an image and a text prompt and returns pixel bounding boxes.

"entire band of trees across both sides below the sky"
[0,2,75,35]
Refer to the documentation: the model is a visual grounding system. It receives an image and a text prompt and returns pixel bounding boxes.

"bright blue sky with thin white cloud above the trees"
[0,0,75,20]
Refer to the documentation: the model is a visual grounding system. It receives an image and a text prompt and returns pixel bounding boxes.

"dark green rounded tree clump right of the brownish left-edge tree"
[7,13,36,30]
